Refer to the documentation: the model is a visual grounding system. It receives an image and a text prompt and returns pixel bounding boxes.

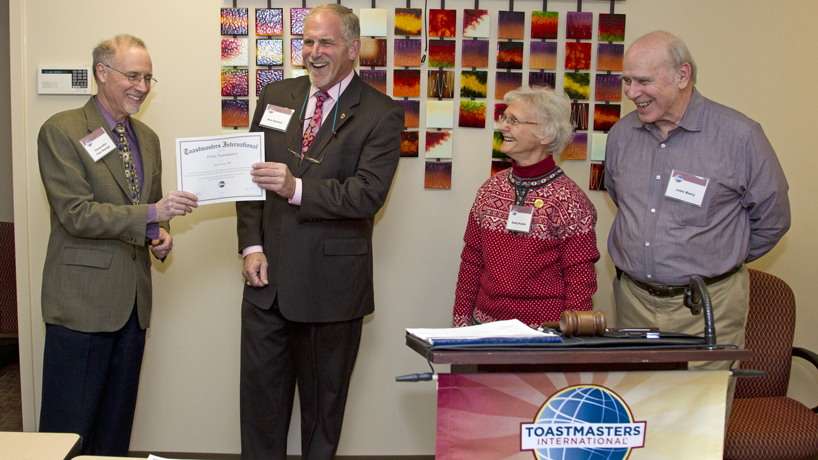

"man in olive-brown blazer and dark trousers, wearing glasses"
[37,35,197,456]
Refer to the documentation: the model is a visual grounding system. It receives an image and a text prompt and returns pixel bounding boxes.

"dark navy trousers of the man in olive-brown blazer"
[40,306,145,457]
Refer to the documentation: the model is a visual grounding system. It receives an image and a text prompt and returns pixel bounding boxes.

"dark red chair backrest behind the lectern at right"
[735,269,795,398]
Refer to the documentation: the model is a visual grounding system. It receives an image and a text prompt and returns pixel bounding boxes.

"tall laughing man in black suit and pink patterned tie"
[236,3,403,459]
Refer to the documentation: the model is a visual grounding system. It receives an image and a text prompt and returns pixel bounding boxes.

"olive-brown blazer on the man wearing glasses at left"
[37,97,167,332]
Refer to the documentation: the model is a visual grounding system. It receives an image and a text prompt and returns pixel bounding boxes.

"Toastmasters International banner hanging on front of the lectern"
[435,371,730,460]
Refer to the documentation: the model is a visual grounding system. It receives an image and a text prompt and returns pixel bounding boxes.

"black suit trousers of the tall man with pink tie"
[240,301,363,460]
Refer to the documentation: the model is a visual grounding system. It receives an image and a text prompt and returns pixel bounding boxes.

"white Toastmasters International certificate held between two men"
[176,132,266,205]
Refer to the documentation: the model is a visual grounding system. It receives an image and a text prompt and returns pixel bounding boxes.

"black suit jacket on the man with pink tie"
[236,75,403,322]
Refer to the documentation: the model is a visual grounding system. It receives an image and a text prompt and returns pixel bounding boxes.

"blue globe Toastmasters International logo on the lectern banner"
[520,385,646,460]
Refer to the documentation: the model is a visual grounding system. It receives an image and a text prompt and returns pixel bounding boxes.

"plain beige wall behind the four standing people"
[10,0,818,455]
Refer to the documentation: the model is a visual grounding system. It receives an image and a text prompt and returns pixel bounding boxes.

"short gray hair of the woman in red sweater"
[503,86,574,155]
